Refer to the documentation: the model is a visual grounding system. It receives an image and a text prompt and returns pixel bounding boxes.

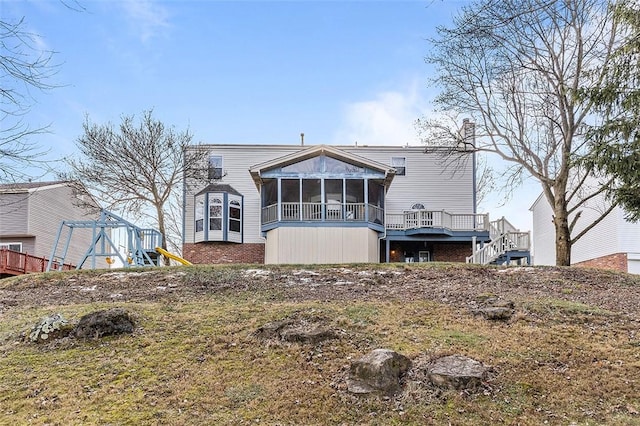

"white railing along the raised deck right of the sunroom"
[386,210,489,231]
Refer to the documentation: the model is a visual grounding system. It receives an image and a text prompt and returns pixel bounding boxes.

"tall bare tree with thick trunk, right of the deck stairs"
[426,0,617,265]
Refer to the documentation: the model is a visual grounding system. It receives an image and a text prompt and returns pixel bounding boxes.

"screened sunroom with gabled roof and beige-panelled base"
[249,145,394,263]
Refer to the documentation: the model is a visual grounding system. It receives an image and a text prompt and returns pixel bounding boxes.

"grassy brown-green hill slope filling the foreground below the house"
[0,264,640,425]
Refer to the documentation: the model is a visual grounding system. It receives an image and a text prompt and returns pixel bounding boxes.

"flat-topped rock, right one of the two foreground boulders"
[427,355,491,389]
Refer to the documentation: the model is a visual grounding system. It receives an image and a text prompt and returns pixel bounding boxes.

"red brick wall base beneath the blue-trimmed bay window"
[182,242,264,264]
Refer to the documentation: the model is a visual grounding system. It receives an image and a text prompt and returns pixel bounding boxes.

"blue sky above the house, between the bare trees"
[0,0,535,229]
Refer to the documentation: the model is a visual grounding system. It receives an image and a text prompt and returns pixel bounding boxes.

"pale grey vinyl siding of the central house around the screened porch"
[184,145,474,243]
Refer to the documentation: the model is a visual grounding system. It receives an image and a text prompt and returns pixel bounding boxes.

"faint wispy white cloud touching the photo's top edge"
[122,0,170,42]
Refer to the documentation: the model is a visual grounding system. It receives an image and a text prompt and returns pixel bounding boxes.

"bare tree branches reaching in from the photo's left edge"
[0,19,57,182]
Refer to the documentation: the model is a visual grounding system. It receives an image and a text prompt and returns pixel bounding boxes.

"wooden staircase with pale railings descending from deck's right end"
[467,217,531,265]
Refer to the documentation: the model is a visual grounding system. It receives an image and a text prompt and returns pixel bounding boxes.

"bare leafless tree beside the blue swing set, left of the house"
[66,111,202,264]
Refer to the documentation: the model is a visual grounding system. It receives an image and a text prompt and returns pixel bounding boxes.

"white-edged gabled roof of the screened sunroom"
[249,145,395,185]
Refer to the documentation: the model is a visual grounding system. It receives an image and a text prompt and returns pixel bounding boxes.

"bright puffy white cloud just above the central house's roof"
[333,83,427,145]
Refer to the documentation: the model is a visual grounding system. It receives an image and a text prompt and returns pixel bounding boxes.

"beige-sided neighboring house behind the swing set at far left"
[0,181,106,274]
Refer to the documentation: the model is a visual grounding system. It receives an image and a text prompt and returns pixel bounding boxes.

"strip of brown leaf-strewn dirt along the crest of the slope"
[0,264,640,321]
